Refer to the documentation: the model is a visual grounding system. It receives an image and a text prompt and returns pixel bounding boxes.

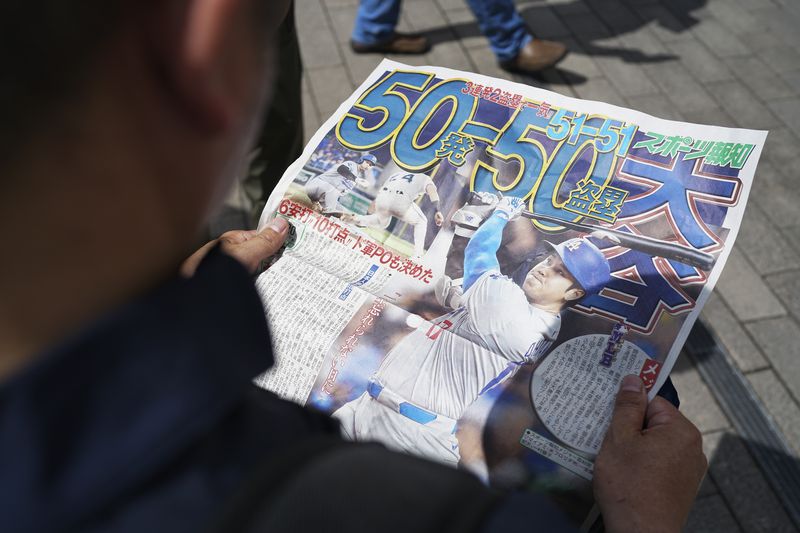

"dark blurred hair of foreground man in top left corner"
[0,0,126,163]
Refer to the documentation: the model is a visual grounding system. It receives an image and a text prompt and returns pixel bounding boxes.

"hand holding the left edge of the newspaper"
[181,217,289,278]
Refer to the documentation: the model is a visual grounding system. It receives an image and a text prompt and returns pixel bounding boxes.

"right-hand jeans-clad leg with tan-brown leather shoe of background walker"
[467,0,567,73]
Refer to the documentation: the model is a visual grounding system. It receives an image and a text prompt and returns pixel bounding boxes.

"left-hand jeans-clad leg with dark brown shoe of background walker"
[350,0,430,54]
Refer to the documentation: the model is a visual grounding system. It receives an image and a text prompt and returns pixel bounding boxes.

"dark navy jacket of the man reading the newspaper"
[0,251,567,533]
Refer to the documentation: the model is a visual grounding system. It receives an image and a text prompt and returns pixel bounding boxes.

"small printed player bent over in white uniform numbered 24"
[342,171,444,258]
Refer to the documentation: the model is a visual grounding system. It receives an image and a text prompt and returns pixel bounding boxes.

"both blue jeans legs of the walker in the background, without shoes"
[352,0,533,61]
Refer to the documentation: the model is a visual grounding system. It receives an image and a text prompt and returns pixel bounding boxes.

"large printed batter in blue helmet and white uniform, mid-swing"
[333,197,610,466]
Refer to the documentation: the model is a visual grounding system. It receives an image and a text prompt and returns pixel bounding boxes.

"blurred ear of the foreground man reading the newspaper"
[148,0,268,135]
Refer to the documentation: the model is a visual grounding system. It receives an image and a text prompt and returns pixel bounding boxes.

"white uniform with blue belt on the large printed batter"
[333,270,561,464]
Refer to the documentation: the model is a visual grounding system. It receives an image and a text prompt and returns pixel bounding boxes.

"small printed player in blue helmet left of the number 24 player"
[305,153,378,214]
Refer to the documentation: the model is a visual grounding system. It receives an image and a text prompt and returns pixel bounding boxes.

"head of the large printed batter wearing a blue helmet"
[522,239,610,312]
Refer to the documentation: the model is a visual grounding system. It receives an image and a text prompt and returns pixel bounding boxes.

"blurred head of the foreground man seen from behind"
[0,0,288,231]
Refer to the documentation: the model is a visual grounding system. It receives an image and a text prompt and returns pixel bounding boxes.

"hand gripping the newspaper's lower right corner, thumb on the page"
[594,376,708,533]
